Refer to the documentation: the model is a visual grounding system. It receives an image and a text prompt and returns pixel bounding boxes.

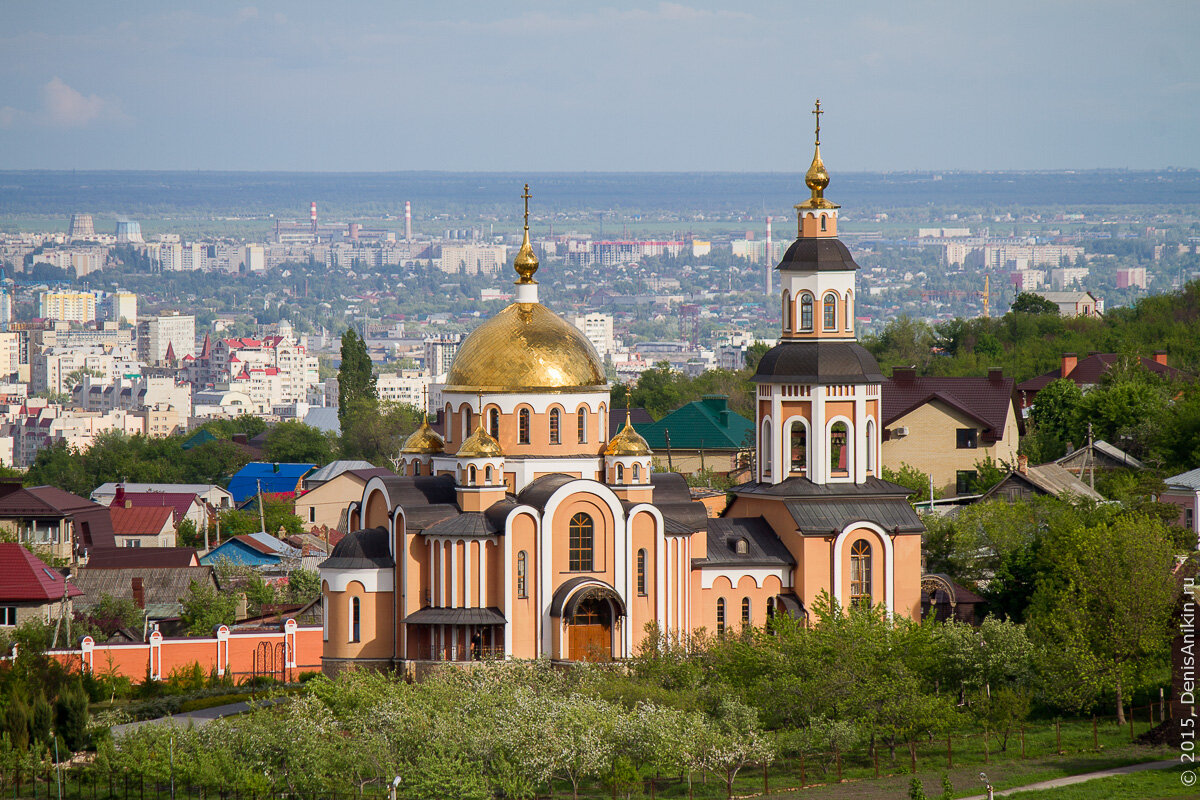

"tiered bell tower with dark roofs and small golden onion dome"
[755,100,883,485]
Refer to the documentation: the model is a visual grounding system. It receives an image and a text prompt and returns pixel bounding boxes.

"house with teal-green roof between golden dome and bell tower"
[633,395,755,474]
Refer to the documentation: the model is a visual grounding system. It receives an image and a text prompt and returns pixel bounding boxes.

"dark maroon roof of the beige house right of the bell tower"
[882,369,1020,441]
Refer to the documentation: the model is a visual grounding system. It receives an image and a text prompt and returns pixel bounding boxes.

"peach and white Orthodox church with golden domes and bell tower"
[320,102,923,672]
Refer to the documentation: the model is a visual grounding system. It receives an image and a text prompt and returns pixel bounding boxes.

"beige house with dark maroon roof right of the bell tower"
[882,367,1021,495]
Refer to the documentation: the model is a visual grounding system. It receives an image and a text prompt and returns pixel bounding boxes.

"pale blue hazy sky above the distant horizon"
[0,0,1200,172]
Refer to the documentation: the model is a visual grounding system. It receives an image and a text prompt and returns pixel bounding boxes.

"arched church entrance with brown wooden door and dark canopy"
[550,577,625,661]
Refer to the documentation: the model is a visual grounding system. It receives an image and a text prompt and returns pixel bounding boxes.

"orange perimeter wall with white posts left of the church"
[47,626,323,684]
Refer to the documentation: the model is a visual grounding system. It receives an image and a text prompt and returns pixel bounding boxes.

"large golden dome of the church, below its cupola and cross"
[445,302,606,393]
